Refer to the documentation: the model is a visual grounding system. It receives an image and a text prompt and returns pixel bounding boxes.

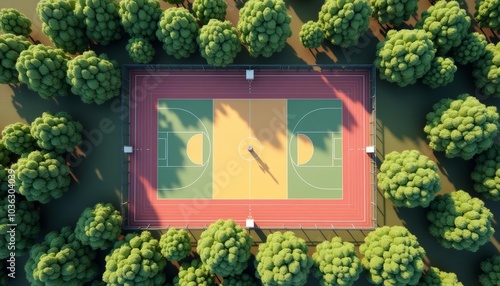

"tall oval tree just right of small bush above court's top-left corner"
[156,8,199,59]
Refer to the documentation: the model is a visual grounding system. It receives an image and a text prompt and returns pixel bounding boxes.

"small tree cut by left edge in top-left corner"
[0,8,31,38]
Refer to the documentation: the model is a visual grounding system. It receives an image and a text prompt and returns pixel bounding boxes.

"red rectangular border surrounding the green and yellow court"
[127,70,375,229]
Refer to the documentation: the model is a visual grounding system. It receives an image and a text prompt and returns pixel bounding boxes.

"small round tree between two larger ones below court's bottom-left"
[160,228,191,261]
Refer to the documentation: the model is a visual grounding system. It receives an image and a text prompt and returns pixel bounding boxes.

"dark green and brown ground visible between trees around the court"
[0,0,500,285]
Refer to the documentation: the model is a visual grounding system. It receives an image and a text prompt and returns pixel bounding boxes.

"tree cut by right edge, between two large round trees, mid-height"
[471,144,500,201]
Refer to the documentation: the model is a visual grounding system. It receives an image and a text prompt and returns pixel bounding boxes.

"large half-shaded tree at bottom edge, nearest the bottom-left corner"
[24,227,97,286]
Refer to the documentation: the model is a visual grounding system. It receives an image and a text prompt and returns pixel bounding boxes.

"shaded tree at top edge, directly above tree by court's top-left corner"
[75,0,123,45]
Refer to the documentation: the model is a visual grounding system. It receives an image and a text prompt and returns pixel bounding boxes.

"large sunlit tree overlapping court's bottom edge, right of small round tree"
[196,219,253,277]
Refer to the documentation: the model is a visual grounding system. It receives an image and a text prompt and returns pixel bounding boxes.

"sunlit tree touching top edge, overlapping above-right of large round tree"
[416,0,470,55]
